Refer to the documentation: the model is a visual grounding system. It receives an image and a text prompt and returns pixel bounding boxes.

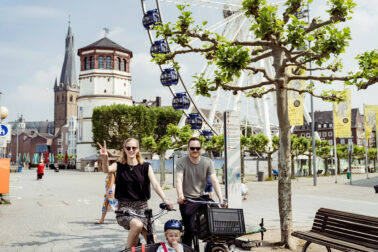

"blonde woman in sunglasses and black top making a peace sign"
[97,138,173,249]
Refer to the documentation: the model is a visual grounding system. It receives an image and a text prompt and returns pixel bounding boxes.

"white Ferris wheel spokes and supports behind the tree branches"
[141,0,311,139]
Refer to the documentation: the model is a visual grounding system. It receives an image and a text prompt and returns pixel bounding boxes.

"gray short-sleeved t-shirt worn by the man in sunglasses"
[176,156,215,198]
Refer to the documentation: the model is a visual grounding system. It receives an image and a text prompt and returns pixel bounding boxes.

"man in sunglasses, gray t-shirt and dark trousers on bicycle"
[176,137,223,246]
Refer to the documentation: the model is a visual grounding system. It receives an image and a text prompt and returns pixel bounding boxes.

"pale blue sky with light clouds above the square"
[0,0,378,125]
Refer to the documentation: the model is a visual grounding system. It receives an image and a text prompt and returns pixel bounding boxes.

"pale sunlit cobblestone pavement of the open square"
[0,170,378,252]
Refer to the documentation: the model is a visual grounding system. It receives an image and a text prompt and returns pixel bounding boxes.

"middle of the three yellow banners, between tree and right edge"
[333,90,352,138]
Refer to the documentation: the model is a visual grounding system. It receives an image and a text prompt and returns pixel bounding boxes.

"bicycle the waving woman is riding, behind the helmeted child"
[115,203,194,252]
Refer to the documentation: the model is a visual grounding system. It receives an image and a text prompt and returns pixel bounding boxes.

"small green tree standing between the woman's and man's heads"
[142,124,193,188]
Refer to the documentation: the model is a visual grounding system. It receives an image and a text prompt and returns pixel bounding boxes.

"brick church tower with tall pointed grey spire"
[54,25,79,133]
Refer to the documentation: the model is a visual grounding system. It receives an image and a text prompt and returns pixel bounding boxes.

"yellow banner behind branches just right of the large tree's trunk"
[287,67,306,126]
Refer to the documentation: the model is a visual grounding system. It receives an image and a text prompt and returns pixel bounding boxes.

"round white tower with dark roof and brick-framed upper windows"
[77,37,133,165]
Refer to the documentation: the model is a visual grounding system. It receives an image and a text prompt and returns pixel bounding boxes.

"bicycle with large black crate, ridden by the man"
[184,198,266,252]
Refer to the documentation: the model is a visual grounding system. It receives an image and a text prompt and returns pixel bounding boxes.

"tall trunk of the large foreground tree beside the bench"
[274,85,295,249]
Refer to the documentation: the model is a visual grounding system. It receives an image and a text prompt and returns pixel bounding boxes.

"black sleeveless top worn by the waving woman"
[115,162,151,201]
